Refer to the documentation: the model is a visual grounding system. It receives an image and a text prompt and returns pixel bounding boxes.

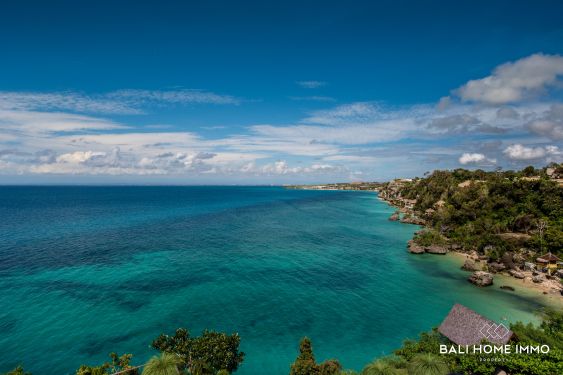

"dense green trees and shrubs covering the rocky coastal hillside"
[382,164,563,259]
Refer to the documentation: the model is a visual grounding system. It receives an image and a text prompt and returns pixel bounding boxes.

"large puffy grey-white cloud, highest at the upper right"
[455,53,563,104]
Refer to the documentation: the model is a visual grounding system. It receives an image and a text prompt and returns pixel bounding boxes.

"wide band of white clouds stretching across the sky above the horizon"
[0,53,563,183]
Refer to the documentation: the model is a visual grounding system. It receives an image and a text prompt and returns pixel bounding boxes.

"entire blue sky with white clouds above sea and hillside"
[0,0,563,184]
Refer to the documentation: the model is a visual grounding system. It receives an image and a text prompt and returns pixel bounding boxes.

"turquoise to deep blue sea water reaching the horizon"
[0,187,548,375]
